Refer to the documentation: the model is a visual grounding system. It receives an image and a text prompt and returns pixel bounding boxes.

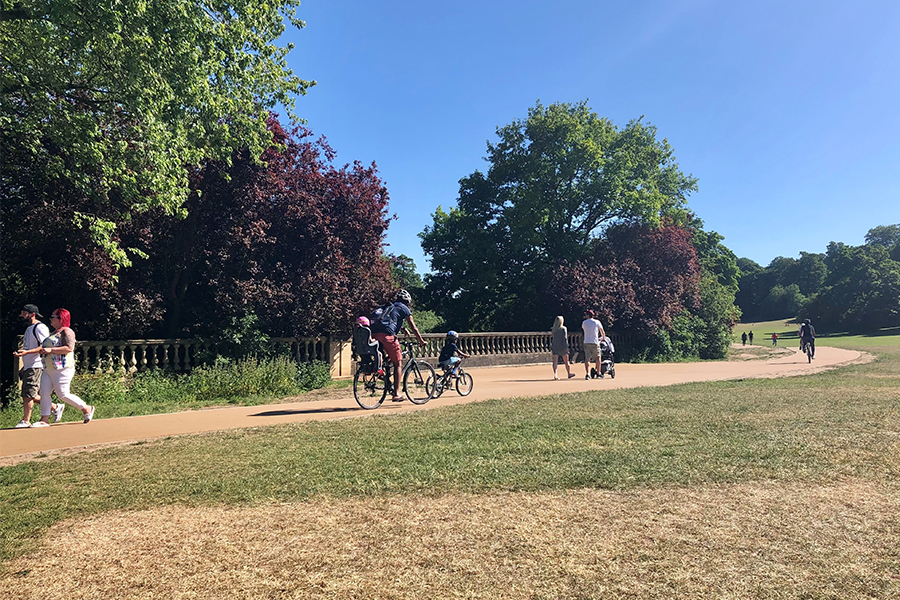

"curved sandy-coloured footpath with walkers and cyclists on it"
[0,347,863,465]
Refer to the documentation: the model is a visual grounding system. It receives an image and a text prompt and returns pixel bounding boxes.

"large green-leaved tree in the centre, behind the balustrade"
[421,102,696,330]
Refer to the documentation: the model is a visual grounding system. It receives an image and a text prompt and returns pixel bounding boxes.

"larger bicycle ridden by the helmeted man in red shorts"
[353,342,436,410]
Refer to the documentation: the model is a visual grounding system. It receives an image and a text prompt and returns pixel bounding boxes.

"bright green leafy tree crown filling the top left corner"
[0,0,314,265]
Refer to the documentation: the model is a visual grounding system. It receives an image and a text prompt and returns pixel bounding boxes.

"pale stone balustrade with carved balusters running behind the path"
[14,331,630,379]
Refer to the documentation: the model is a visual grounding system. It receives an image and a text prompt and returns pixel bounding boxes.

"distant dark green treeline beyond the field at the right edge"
[735,224,900,331]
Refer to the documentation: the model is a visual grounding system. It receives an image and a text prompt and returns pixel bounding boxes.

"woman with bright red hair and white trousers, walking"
[32,308,94,427]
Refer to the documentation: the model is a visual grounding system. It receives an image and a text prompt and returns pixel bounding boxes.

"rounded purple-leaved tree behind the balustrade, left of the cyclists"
[141,119,392,335]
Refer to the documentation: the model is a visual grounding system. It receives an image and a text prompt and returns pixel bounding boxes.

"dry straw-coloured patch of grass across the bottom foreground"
[0,481,900,600]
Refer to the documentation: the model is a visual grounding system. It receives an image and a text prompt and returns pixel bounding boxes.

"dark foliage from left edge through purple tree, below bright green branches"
[0,117,392,386]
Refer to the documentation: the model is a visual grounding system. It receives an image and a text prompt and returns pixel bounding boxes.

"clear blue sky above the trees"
[284,0,900,273]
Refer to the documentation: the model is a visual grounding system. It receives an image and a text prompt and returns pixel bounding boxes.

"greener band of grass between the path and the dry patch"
[0,340,900,560]
